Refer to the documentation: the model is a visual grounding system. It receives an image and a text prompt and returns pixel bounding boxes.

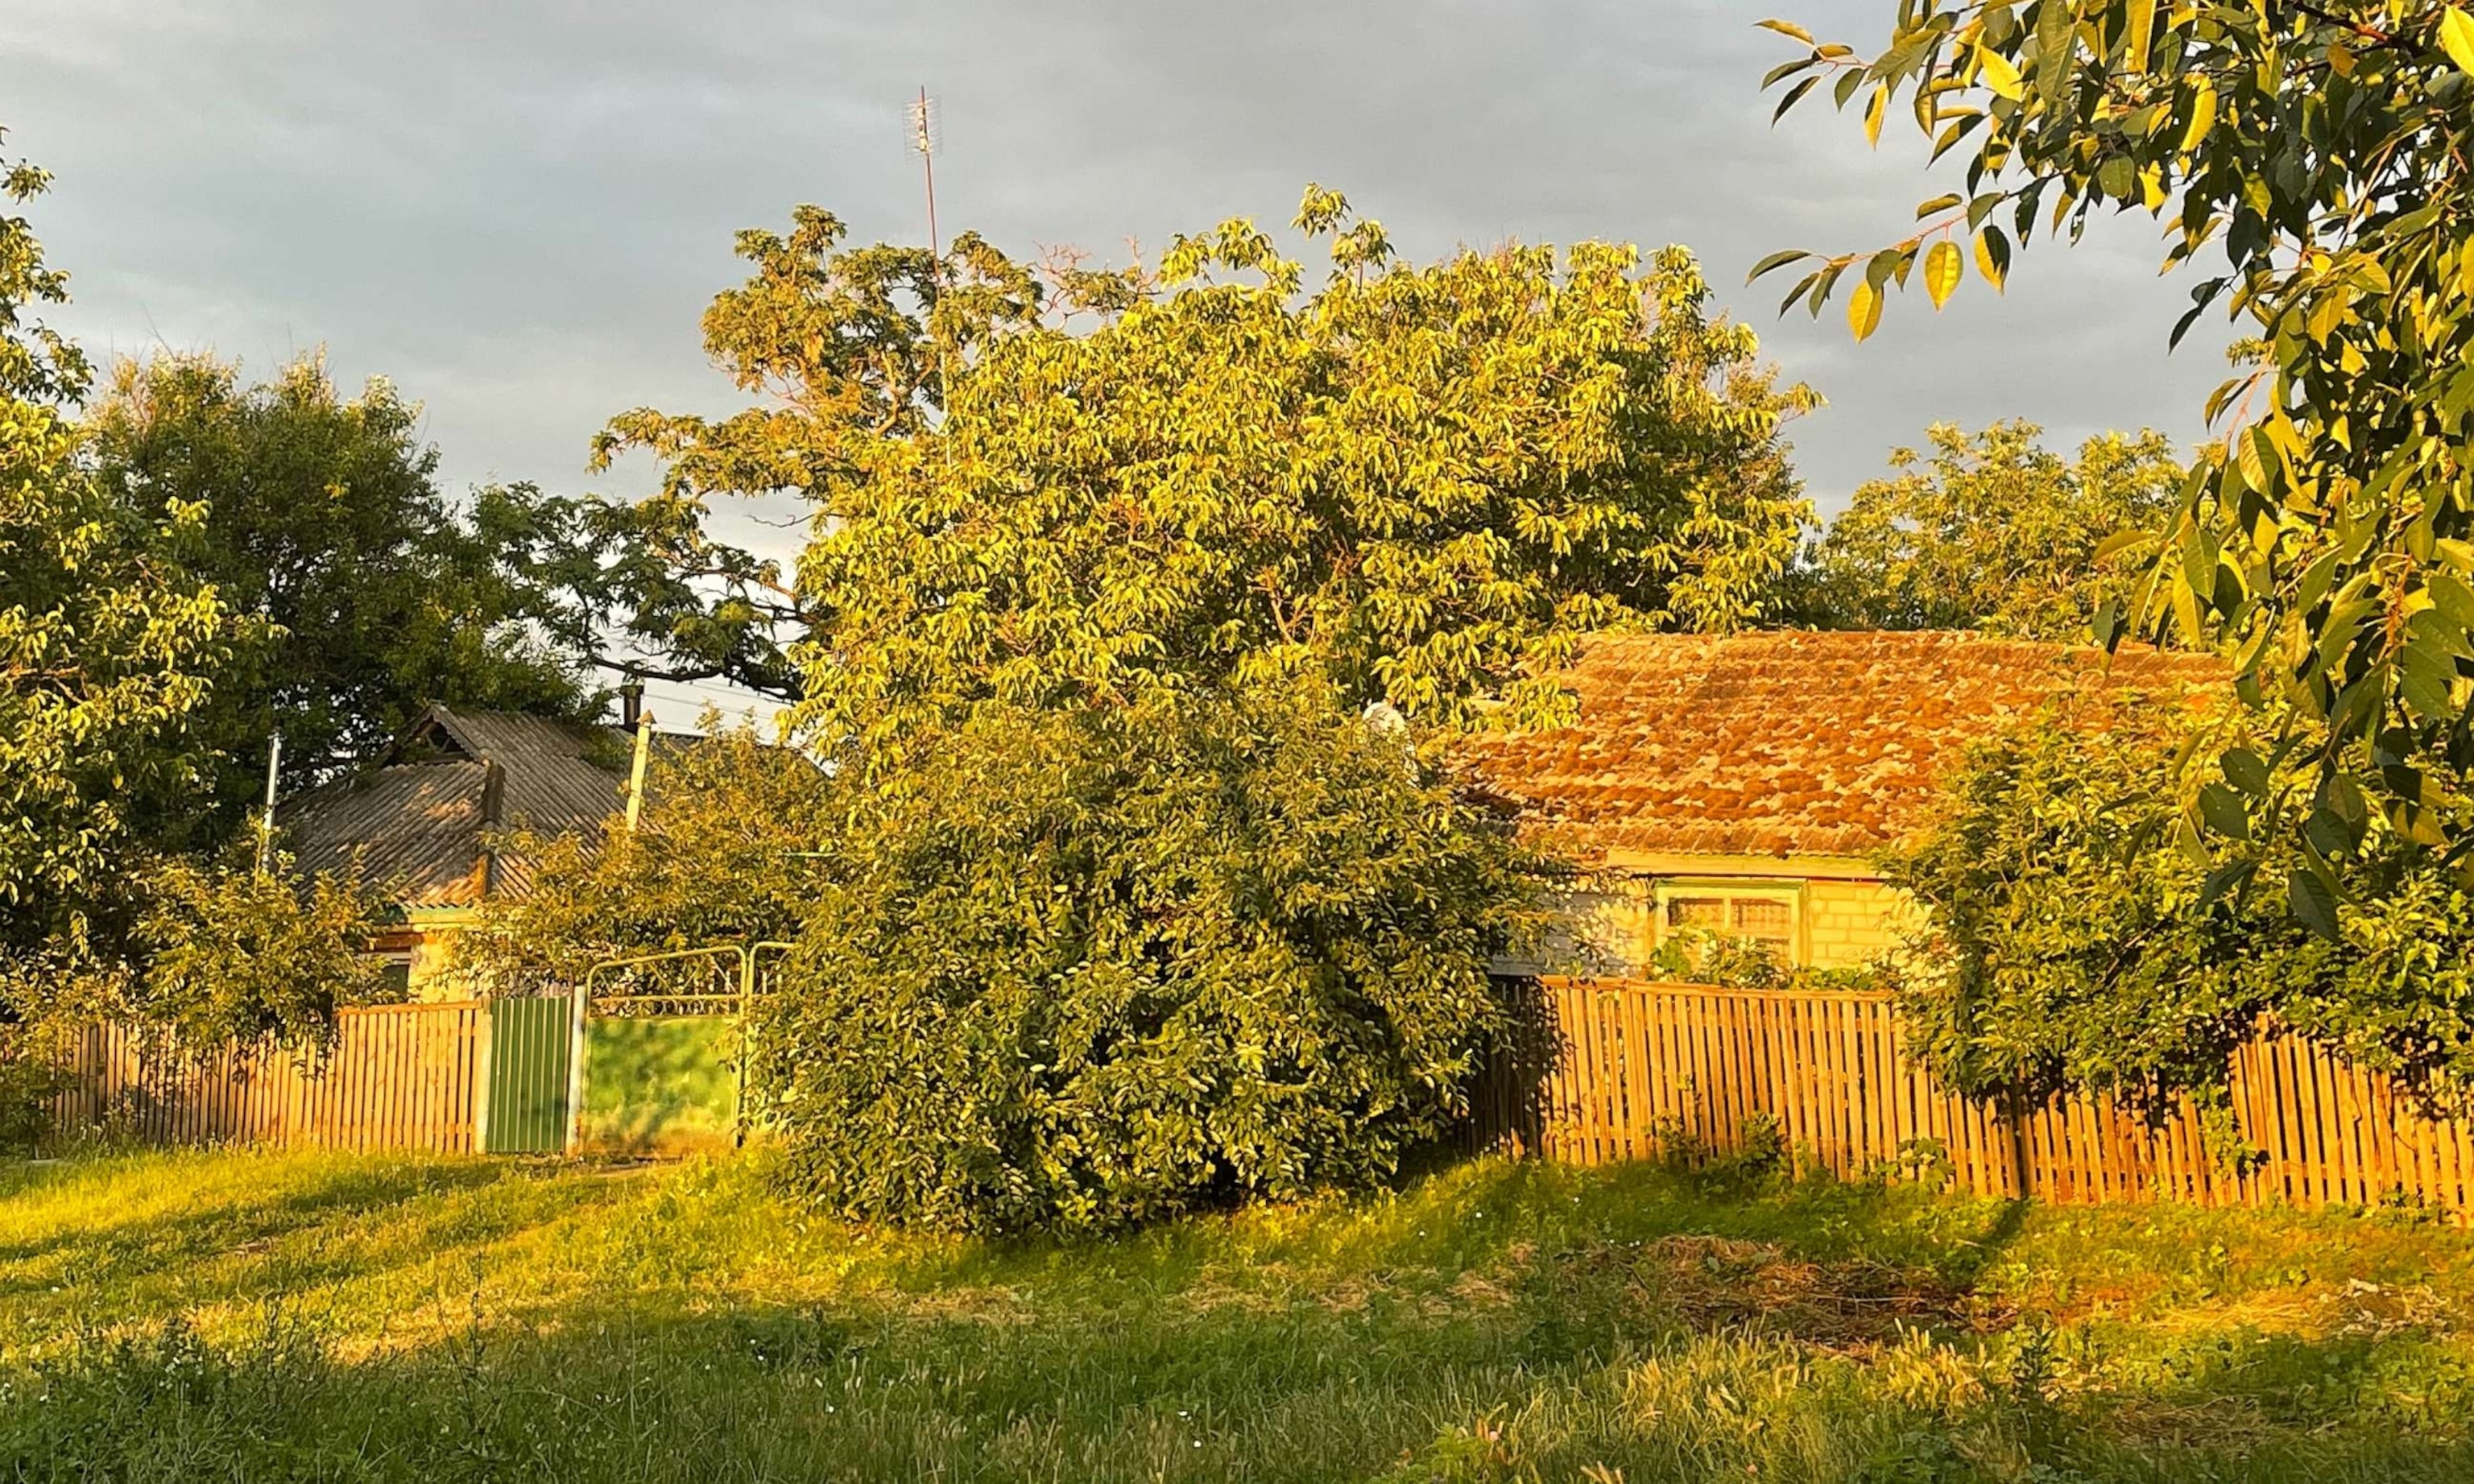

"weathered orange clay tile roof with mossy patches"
[1472,630,2227,858]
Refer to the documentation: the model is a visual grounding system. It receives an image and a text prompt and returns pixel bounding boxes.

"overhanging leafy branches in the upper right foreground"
[1756,0,2474,903]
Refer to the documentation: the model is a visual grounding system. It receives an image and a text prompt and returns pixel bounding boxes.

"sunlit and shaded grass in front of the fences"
[0,1152,2474,1484]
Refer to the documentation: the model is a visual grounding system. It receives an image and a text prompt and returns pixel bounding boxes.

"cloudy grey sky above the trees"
[0,0,2224,722]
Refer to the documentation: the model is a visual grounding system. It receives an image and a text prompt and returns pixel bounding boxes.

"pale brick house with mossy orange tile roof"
[1475,630,2227,969]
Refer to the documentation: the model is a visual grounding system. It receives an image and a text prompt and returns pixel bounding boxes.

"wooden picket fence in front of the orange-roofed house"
[1475,979,2474,1222]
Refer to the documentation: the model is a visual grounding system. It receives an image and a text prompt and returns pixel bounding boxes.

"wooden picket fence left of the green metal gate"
[55,999,490,1155]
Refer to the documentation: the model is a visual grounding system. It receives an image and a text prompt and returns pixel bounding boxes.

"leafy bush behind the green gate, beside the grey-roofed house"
[455,727,838,994]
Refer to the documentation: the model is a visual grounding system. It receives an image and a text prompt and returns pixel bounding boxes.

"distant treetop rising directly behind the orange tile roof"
[1806,423,2182,643]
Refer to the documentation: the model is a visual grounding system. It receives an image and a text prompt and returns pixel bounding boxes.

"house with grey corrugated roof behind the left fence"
[275,705,685,999]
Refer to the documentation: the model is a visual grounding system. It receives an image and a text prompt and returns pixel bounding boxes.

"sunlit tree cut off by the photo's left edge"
[0,142,245,953]
